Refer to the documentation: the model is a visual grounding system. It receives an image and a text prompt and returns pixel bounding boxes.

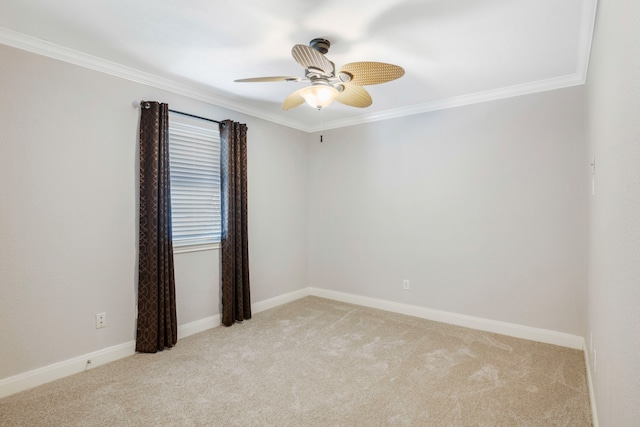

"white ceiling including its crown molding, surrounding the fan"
[0,0,597,131]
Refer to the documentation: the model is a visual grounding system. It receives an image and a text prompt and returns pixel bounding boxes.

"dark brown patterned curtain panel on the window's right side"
[220,120,251,326]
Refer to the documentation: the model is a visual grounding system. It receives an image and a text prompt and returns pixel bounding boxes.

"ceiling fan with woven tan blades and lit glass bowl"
[235,38,404,111]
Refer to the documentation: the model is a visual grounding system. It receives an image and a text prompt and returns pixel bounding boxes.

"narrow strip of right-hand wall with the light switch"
[586,0,640,426]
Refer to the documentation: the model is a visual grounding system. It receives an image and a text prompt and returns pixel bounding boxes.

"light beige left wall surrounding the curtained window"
[0,45,308,379]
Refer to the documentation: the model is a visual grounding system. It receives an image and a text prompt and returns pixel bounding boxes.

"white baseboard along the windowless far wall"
[309,288,584,350]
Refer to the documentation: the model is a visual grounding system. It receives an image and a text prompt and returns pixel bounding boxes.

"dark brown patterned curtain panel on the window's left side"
[136,101,178,353]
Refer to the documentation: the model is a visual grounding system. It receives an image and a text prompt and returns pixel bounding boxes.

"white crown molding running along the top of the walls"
[0,13,597,133]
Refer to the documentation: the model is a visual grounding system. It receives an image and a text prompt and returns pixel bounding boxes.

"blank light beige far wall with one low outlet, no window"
[309,87,586,336]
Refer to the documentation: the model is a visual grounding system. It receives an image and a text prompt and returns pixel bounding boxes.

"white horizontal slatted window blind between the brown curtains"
[169,120,220,247]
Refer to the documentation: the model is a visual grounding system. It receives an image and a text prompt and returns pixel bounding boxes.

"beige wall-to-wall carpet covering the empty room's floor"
[0,297,591,426]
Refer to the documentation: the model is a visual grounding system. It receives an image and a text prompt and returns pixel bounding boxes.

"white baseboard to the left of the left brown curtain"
[0,341,136,398]
